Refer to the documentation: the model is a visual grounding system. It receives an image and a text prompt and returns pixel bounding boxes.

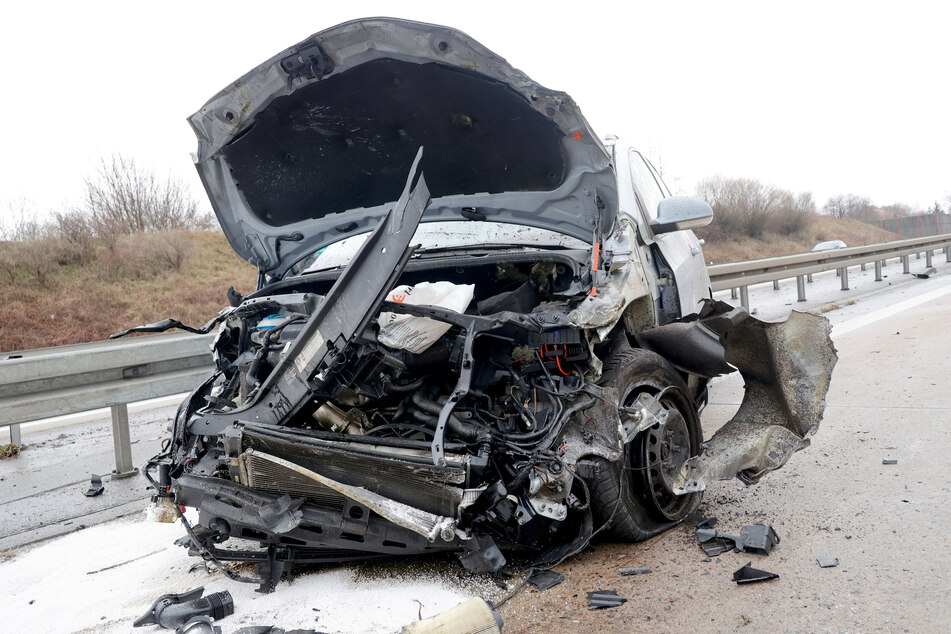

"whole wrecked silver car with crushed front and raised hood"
[138,19,835,589]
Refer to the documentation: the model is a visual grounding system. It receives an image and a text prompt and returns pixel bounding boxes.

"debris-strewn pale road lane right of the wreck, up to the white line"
[502,288,951,632]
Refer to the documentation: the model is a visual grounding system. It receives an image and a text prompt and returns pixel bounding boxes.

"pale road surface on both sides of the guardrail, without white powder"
[0,258,951,632]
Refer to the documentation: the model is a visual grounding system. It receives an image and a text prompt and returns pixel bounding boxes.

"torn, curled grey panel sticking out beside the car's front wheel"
[674,311,837,494]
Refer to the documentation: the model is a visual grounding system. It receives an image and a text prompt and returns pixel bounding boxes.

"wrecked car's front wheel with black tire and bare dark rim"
[585,341,702,541]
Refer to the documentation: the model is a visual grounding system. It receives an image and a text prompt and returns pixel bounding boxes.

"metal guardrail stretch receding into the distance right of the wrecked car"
[707,234,951,310]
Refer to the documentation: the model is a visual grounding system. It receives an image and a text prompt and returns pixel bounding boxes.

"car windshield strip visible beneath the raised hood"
[294,221,591,275]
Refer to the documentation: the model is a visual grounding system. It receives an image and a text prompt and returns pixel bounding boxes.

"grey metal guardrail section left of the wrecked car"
[0,333,214,477]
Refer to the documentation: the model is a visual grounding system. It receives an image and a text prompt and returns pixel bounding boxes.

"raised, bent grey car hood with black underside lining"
[189,18,617,276]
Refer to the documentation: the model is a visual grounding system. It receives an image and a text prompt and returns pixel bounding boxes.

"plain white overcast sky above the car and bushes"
[0,0,951,213]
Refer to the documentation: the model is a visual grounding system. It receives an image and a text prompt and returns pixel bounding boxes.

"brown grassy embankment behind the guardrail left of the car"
[0,231,256,352]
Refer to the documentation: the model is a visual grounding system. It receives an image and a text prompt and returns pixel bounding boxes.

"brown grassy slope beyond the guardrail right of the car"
[698,216,901,264]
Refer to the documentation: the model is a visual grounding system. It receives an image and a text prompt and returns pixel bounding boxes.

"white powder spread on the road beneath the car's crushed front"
[0,517,483,634]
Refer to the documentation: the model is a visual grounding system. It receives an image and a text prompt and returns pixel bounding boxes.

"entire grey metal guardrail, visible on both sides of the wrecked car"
[0,234,951,476]
